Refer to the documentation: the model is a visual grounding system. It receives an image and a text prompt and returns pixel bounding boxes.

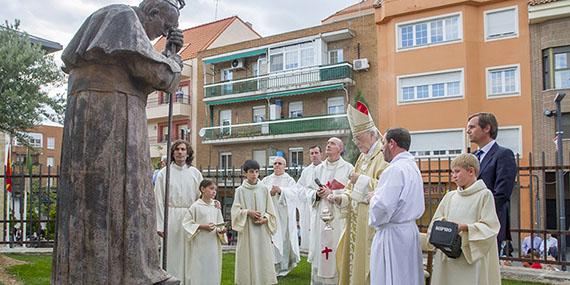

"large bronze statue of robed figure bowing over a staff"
[52,0,184,284]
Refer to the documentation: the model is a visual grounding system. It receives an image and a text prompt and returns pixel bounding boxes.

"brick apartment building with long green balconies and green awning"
[196,11,378,169]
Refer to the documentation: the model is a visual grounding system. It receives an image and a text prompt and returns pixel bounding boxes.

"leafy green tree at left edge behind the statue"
[0,20,65,144]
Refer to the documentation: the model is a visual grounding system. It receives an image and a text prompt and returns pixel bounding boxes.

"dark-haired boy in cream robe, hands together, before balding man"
[231,160,277,285]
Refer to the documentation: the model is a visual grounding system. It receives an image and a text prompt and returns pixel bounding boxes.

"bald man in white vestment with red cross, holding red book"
[307,137,354,285]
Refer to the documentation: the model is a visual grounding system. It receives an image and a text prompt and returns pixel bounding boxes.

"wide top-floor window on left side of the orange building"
[397,14,462,49]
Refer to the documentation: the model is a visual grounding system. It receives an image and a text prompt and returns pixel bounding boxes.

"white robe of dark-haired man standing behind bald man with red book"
[297,163,320,251]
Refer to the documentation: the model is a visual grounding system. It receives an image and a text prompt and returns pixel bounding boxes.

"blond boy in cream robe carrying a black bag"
[427,154,501,285]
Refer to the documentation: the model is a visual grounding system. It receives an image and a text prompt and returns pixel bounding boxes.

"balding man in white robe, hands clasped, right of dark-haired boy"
[261,157,301,276]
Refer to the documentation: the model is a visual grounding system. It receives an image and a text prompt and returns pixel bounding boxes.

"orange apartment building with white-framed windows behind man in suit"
[375,0,533,225]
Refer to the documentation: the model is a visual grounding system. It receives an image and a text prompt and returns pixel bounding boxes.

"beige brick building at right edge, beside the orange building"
[528,0,570,229]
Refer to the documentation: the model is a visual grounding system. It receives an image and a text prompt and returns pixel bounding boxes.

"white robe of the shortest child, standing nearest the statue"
[182,199,224,285]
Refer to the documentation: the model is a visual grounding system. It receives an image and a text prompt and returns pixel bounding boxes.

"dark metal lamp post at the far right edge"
[544,93,566,271]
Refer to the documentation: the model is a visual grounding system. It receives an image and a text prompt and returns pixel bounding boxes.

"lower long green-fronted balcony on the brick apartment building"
[199,114,350,144]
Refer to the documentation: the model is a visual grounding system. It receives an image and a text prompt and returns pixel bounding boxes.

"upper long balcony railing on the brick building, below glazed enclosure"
[204,62,352,98]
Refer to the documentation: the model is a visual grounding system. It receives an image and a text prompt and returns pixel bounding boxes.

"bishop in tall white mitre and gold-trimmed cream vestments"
[335,102,388,285]
